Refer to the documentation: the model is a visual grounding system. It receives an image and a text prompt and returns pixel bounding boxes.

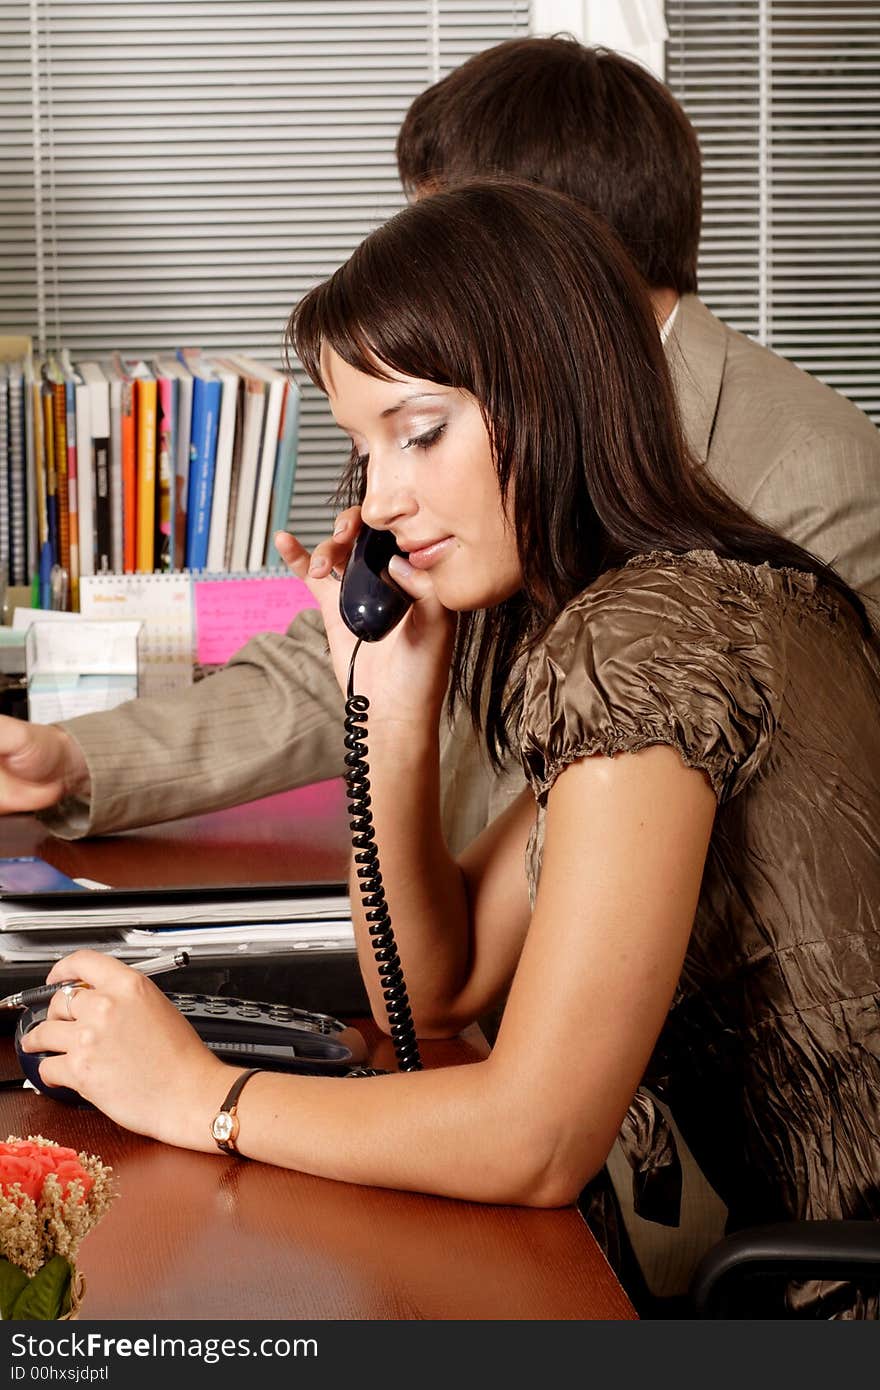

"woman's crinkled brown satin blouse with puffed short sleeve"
[520,550,880,1318]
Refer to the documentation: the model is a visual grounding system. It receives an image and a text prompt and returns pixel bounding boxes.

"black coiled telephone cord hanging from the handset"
[345,641,421,1072]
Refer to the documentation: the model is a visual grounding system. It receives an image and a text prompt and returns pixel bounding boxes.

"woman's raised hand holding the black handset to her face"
[274,507,455,727]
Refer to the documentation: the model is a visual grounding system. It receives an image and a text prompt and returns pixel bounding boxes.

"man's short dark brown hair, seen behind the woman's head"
[398,38,701,295]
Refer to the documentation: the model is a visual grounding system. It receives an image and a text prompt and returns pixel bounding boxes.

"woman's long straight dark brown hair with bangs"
[288,179,866,760]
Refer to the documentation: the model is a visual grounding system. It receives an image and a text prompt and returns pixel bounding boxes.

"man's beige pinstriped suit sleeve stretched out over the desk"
[43,610,343,838]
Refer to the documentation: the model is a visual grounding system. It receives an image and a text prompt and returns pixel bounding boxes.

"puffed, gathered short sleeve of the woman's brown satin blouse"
[520,552,784,803]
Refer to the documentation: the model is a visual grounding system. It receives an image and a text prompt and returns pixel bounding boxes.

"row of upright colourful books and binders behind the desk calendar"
[0,336,300,612]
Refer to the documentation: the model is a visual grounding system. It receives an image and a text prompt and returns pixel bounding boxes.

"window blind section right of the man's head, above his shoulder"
[666,0,880,421]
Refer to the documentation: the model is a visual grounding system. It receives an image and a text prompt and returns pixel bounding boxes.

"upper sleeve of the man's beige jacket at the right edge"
[748,431,880,600]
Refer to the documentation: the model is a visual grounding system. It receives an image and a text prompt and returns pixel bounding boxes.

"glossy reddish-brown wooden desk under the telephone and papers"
[0,800,635,1321]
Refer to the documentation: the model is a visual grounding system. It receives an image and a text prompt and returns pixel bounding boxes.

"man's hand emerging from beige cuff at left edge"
[0,714,90,815]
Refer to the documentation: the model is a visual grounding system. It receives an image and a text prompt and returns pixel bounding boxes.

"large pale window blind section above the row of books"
[0,0,530,543]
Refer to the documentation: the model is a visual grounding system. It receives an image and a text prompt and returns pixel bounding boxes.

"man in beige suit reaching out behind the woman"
[0,39,880,849]
